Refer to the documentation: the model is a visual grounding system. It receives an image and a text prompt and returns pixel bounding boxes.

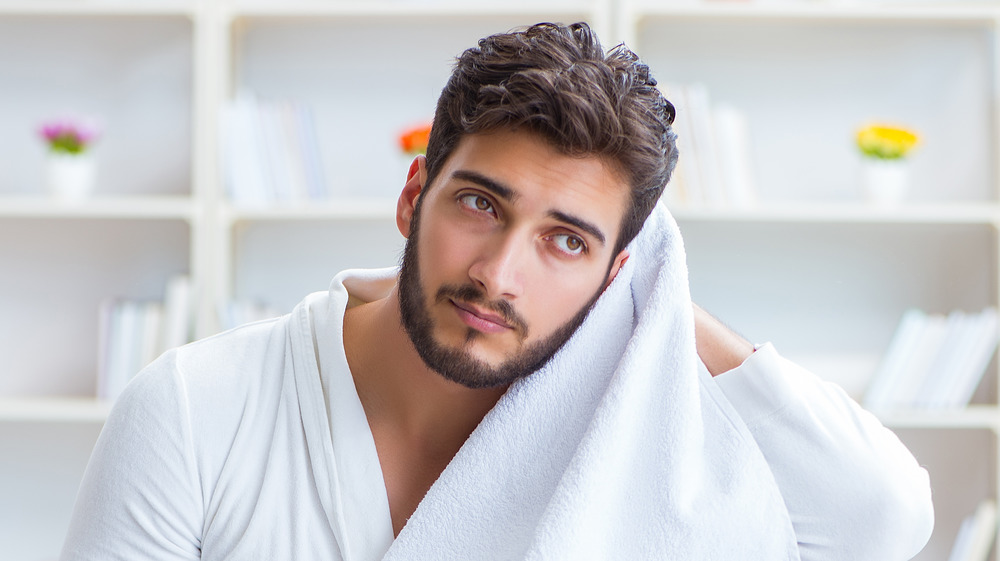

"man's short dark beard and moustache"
[399,199,602,389]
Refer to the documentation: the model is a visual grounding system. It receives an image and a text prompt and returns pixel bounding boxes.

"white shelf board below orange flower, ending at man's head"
[223,198,396,223]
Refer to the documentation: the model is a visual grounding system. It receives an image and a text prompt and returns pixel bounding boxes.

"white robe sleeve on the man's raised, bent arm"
[713,344,934,561]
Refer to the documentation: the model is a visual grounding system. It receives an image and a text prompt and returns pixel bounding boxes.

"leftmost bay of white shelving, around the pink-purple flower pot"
[0,1,205,561]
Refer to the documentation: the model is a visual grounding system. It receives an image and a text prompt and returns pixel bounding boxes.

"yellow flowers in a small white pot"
[857,124,920,205]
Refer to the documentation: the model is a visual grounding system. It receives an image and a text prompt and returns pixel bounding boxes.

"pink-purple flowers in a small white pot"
[38,119,98,200]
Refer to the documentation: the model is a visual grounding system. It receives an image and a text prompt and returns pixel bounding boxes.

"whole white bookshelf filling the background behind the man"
[0,0,1000,561]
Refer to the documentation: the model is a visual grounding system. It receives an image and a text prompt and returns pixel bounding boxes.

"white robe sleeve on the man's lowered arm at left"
[61,351,204,561]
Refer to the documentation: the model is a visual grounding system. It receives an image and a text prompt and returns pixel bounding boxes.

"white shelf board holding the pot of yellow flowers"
[671,203,1000,225]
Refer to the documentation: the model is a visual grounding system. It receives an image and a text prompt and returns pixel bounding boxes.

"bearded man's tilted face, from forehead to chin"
[398,131,628,387]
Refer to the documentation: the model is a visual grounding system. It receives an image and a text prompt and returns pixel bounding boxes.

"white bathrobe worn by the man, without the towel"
[62,270,931,561]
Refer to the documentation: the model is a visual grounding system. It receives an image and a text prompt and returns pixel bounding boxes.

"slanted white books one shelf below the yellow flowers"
[863,308,998,411]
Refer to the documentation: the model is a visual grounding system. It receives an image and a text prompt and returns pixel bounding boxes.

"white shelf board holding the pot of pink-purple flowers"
[0,197,196,221]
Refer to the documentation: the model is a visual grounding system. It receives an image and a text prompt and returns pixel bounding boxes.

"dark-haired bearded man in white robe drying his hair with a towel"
[63,24,932,560]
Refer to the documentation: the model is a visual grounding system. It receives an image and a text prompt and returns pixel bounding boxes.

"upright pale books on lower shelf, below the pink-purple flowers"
[97,275,193,400]
